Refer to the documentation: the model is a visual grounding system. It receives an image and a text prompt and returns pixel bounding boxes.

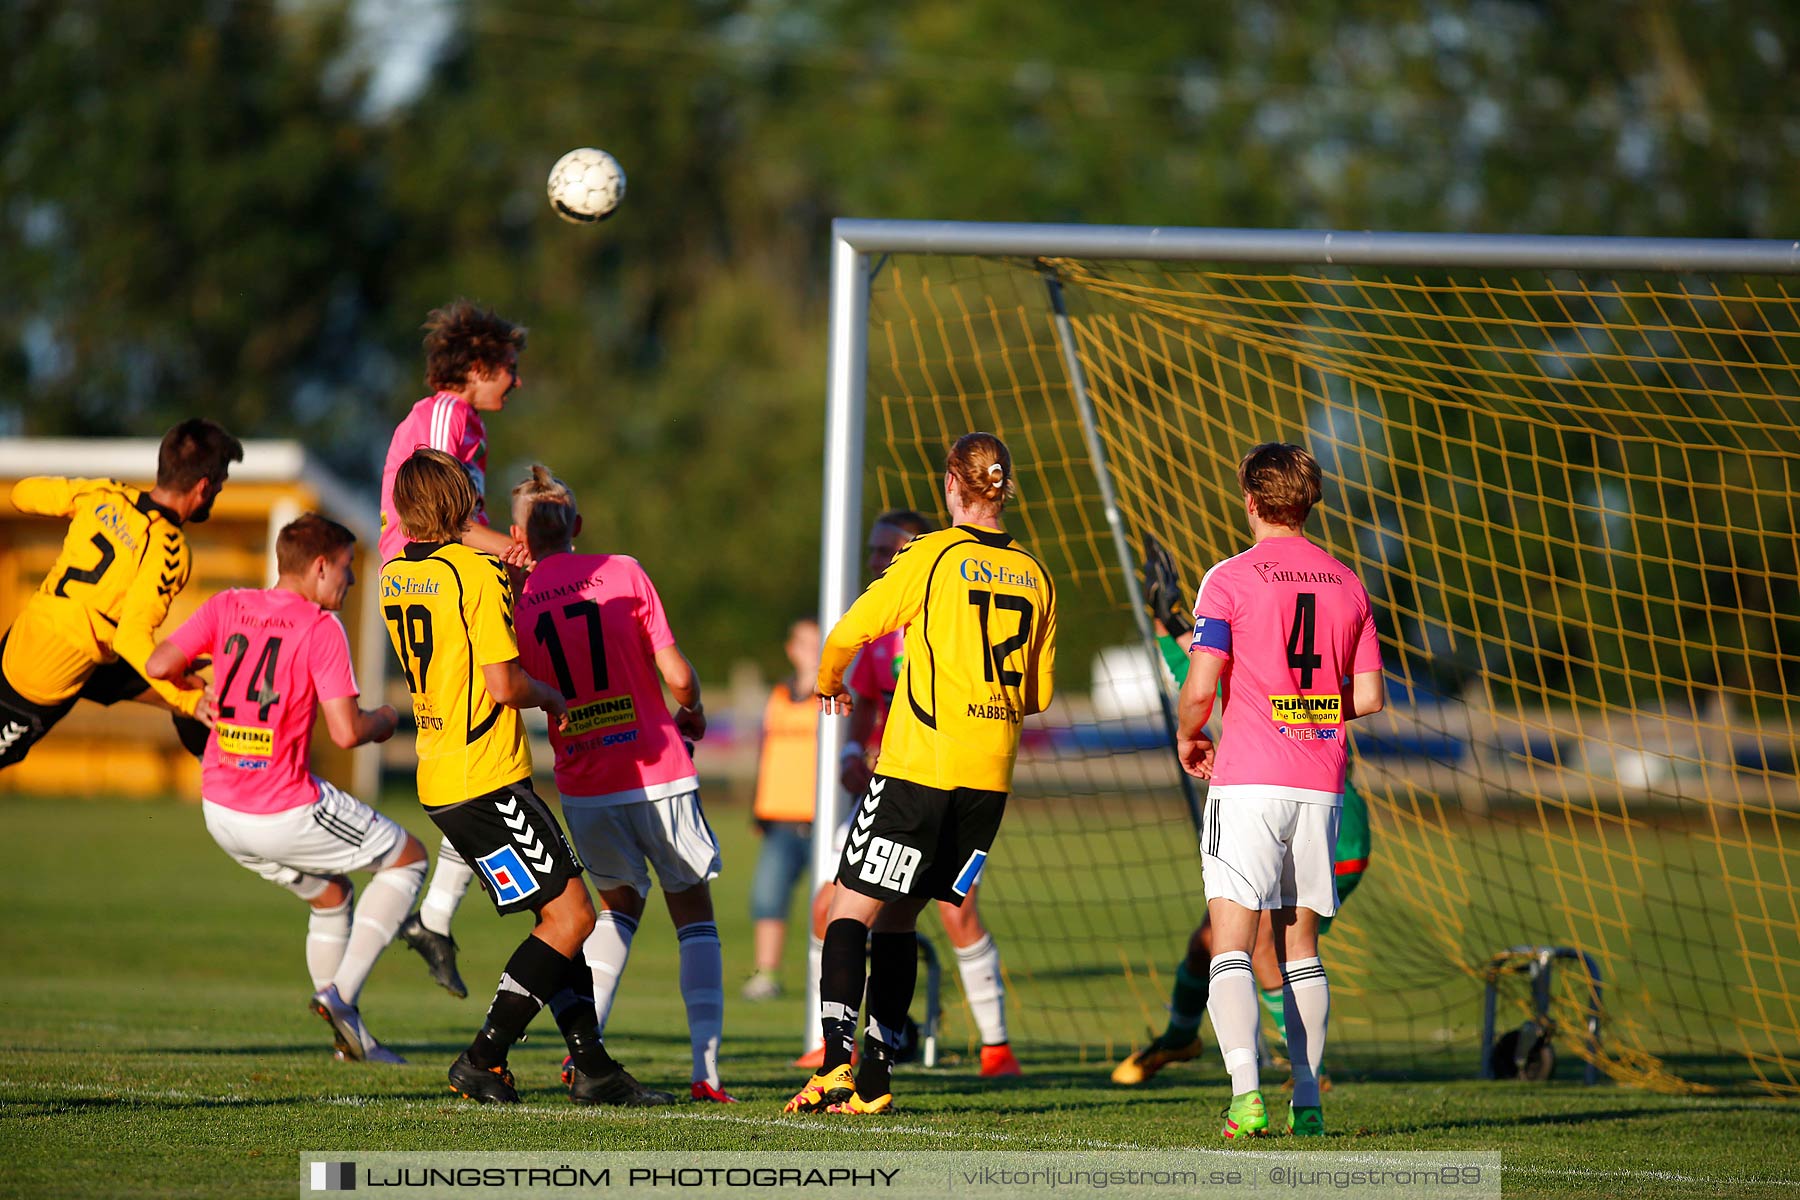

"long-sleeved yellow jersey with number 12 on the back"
[819,525,1057,792]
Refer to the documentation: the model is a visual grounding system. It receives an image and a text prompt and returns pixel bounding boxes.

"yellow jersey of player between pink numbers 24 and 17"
[382,542,531,808]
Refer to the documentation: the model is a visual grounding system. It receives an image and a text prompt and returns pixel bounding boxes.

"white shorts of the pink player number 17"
[563,792,718,896]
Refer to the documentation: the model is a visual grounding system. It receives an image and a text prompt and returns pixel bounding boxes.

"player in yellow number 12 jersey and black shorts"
[785,434,1057,1114]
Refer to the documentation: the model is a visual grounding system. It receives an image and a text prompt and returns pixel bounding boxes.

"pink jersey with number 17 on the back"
[513,554,700,808]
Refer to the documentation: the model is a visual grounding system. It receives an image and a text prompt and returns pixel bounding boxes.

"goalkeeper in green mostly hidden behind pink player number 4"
[1112,536,1370,1087]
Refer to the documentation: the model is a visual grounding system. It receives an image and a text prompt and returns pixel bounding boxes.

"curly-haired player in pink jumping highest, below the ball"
[382,300,529,999]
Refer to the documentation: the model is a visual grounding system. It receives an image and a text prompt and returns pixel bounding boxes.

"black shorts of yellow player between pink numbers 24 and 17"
[425,779,581,916]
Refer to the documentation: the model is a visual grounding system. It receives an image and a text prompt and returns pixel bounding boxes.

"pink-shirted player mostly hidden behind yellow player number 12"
[794,509,1022,1076]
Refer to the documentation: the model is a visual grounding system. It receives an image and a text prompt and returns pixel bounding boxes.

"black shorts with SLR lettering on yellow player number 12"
[837,775,1006,905]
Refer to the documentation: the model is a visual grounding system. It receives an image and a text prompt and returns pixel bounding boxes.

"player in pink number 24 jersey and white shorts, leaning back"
[148,513,425,1063]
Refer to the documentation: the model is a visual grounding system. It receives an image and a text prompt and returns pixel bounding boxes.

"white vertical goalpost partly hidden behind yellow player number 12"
[803,237,869,1043]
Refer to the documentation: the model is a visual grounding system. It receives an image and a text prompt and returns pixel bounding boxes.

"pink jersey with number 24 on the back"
[169,588,358,813]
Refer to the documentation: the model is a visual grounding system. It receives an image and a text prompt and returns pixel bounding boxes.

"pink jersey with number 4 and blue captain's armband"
[1190,534,1381,804]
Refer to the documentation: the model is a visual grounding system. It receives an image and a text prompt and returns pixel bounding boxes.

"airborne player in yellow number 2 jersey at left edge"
[0,417,243,768]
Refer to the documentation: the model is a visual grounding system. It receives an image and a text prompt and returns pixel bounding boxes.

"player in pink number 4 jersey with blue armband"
[1177,443,1386,1139]
